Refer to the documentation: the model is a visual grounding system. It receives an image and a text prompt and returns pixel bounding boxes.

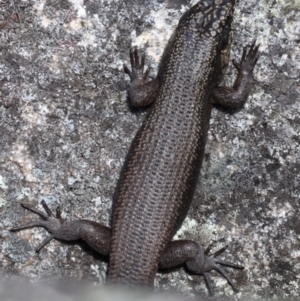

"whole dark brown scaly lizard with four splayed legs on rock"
[12,0,259,294]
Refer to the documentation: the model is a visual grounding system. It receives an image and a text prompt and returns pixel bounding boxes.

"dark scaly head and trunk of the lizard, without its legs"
[108,0,235,285]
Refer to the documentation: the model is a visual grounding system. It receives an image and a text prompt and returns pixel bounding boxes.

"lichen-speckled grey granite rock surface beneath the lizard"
[0,0,300,300]
